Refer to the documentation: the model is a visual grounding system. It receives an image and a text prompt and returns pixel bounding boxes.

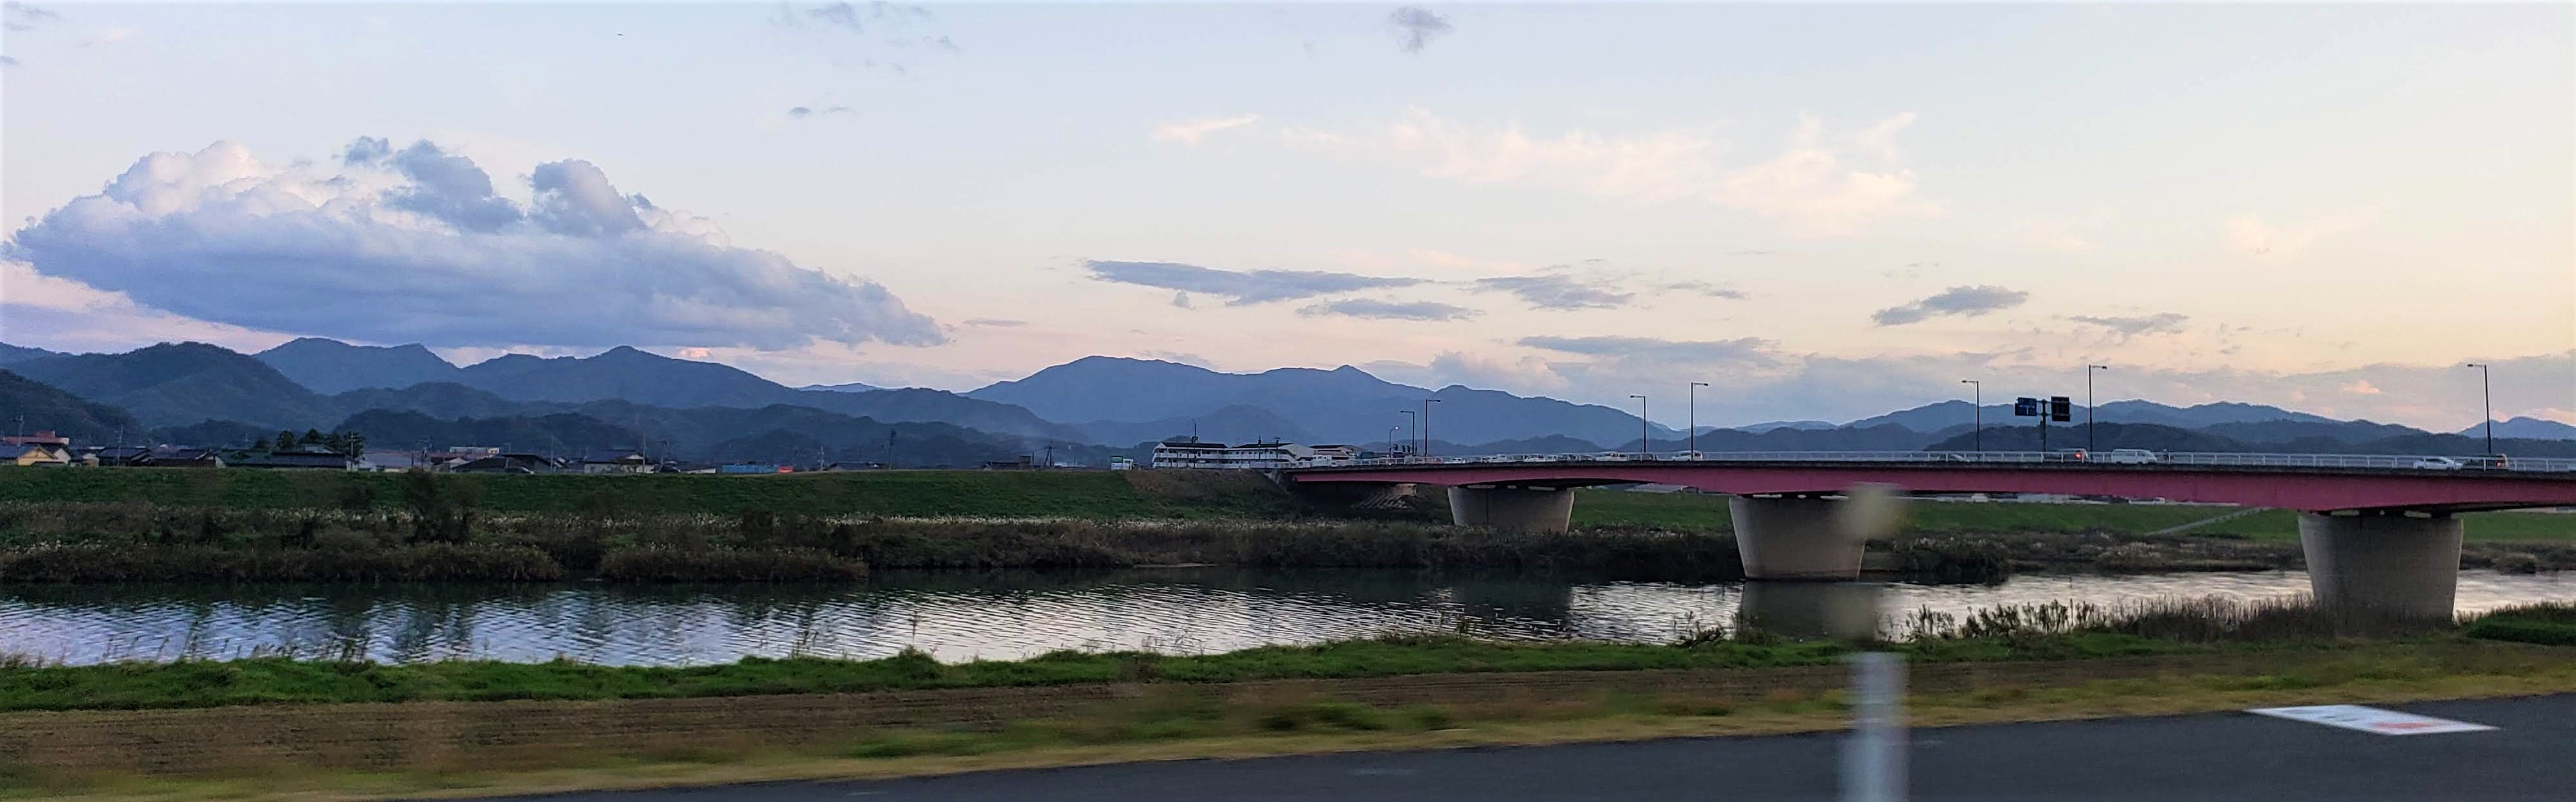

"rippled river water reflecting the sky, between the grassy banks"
[0,570,2576,665]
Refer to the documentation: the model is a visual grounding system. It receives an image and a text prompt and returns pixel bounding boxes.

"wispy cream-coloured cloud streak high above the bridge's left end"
[1283,108,1937,238]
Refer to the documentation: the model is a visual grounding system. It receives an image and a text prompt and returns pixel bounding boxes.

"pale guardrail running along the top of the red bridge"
[1347,449,2576,472]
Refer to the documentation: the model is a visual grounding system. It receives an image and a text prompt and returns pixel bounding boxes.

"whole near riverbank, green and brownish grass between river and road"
[0,603,2576,799]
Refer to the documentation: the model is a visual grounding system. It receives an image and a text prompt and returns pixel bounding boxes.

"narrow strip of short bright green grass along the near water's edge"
[0,632,2208,712]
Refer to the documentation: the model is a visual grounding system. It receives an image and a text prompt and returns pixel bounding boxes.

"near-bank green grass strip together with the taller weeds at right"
[0,598,2576,712]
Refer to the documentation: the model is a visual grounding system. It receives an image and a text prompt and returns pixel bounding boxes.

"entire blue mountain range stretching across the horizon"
[0,338,2576,462]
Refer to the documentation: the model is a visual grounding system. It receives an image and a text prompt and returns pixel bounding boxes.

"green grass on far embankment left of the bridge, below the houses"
[0,469,1286,521]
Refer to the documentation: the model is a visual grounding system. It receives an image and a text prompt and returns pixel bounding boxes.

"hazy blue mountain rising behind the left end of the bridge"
[966,356,1669,443]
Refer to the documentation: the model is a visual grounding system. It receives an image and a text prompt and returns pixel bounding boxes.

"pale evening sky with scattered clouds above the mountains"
[0,3,2576,430]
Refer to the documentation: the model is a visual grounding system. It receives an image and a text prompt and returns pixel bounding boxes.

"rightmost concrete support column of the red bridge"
[2298,513,2460,619]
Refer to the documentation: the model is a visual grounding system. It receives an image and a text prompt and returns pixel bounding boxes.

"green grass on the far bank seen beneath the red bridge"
[1574,490,2576,542]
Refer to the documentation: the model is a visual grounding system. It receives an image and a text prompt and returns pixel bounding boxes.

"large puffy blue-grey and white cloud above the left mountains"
[0,139,940,348]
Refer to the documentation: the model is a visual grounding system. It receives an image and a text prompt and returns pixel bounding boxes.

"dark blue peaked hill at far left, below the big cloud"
[10,343,338,430]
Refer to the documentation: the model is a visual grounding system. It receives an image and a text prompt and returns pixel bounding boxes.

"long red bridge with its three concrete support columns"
[1283,451,2576,616]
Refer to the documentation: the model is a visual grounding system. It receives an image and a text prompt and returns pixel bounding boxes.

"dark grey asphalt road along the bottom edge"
[468,696,2576,802]
